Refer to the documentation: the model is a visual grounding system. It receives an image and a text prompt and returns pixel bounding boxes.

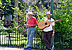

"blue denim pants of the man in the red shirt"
[26,27,36,48]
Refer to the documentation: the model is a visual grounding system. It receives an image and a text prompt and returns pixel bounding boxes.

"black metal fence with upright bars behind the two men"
[0,29,46,49]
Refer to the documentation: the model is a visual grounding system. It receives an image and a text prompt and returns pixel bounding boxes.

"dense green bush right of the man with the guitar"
[54,0,72,48]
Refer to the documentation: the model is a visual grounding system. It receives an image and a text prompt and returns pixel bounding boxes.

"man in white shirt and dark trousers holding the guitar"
[43,12,55,50]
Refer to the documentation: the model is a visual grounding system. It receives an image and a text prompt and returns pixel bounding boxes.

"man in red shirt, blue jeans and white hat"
[24,12,37,49]
